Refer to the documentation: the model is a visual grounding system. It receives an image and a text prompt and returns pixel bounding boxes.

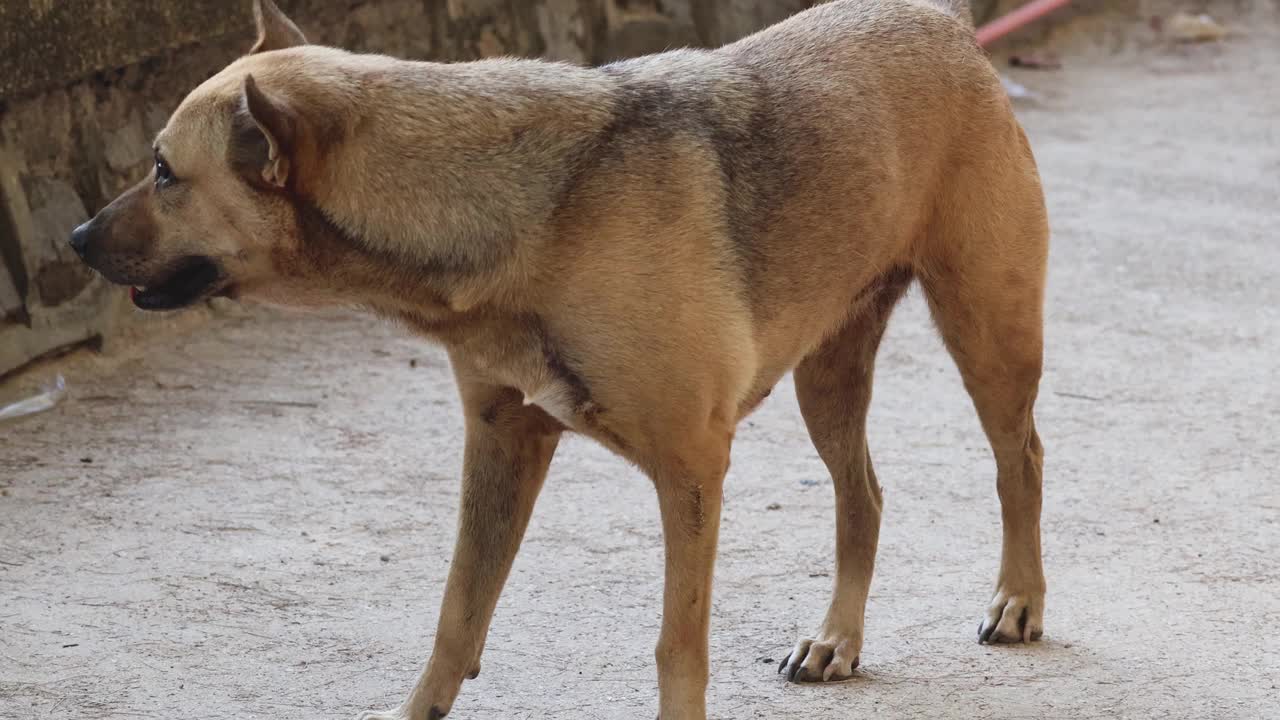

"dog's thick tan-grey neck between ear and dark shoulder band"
[285,55,609,322]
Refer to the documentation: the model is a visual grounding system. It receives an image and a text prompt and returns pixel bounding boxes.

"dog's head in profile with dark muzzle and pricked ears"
[70,0,353,310]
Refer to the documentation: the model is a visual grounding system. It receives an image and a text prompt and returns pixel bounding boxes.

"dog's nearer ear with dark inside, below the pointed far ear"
[232,74,298,188]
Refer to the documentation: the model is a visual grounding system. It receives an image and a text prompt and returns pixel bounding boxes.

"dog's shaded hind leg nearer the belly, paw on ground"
[778,269,911,682]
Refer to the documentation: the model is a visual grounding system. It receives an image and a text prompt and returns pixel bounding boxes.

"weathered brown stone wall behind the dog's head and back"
[0,0,812,375]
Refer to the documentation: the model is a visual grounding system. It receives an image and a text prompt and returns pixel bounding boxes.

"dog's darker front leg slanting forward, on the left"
[361,379,562,720]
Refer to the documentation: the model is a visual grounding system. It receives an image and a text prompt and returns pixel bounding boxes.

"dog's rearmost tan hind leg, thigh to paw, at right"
[918,128,1048,642]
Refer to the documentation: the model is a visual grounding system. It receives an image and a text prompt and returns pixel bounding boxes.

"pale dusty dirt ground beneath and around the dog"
[0,9,1280,720]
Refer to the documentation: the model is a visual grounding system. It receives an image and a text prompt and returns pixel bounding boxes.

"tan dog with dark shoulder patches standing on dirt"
[70,0,1048,720]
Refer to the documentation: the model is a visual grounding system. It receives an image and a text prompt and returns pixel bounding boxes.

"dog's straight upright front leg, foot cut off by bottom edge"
[654,433,728,720]
